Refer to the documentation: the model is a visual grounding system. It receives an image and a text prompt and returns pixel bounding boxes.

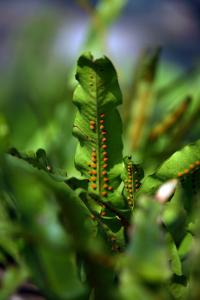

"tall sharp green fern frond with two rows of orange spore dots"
[73,53,122,204]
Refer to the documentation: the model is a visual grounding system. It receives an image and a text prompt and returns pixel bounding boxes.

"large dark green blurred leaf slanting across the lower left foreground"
[5,161,87,300]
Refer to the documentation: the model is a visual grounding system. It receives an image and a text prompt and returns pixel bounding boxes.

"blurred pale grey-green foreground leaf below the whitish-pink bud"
[127,198,171,282]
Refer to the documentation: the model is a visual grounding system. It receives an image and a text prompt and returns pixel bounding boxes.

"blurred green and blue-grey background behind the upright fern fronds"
[0,0,200,171]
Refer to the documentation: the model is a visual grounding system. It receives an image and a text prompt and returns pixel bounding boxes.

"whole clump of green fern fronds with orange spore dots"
[0,49,200,300]
